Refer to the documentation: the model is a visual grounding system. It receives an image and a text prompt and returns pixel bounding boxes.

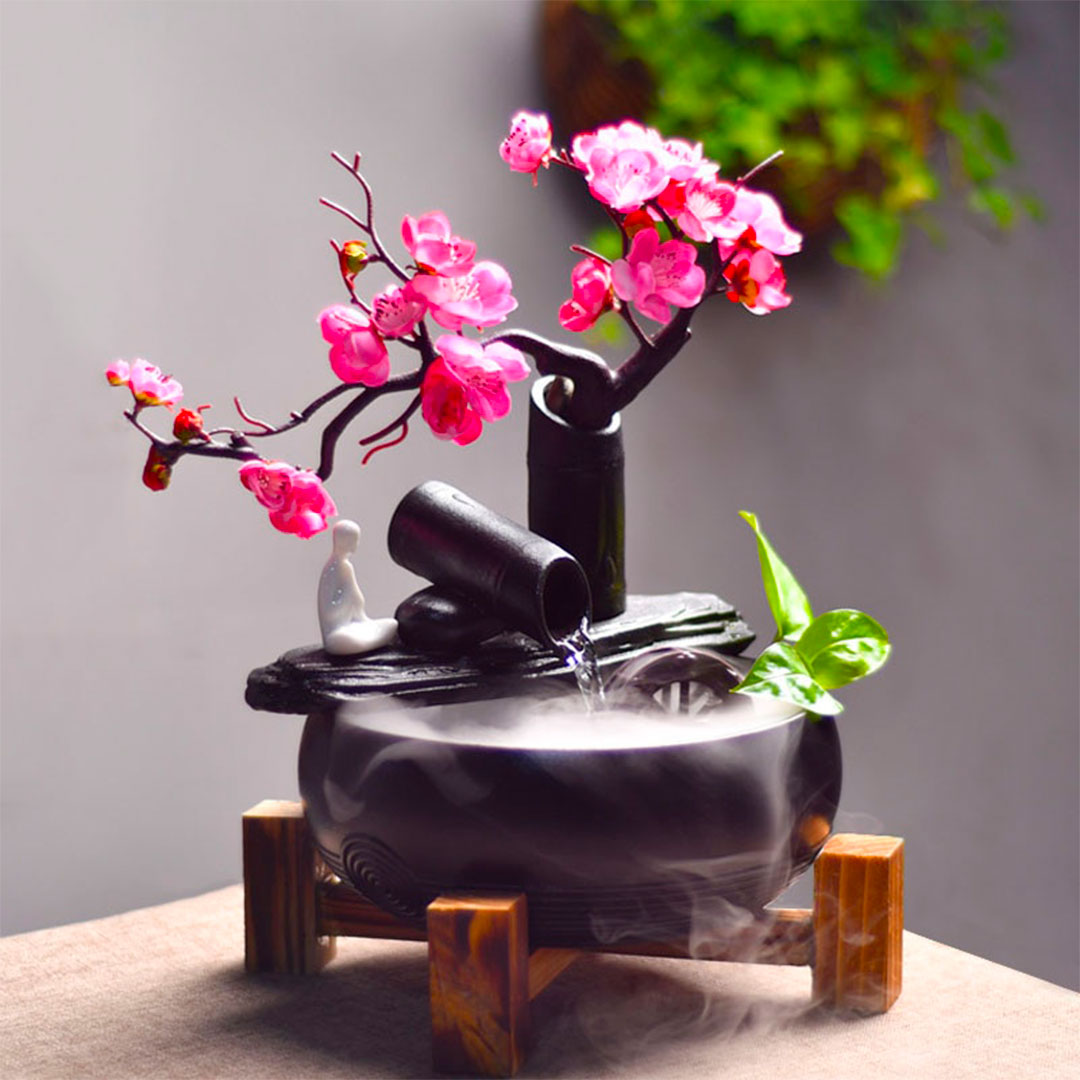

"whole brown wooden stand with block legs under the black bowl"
[243,801,904,1077]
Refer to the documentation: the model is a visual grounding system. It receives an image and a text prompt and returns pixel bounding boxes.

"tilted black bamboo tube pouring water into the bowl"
[387,481,592,645]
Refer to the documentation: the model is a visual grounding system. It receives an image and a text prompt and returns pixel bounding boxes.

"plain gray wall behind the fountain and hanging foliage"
[0,2,1078,986]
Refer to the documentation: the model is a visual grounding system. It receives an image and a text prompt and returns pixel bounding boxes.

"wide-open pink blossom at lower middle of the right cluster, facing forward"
[611,229,705,323]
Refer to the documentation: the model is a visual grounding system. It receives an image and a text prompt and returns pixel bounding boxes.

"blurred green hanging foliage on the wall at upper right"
[580,0,1040,279]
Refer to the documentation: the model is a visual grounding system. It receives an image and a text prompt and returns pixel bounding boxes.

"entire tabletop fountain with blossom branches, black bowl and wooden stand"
[106,107,902,1075]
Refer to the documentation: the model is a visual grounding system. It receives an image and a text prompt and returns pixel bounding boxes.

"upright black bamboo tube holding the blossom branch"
[528,377,626,622]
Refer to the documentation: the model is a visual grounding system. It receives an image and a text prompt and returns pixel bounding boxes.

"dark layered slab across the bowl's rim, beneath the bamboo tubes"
[245,593,754,715]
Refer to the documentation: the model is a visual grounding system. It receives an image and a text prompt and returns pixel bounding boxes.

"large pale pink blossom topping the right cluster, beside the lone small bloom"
[570,120,671,214]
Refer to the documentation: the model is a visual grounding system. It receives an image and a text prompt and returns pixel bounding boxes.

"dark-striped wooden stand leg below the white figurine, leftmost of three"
[243,799,334,975]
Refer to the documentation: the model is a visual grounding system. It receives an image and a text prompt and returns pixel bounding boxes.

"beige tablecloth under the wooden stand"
[0,886,1080,1080]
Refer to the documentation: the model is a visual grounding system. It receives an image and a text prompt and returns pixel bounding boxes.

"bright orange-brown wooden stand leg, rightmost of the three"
[813,835,904,1013]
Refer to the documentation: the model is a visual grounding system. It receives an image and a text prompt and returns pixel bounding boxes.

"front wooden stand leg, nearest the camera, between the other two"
[428,894,529,1077]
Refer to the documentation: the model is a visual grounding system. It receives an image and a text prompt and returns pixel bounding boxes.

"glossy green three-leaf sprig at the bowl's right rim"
[735,510,892,716]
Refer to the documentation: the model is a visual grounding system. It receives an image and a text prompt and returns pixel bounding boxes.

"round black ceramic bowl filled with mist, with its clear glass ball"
[299,650,840,945]
